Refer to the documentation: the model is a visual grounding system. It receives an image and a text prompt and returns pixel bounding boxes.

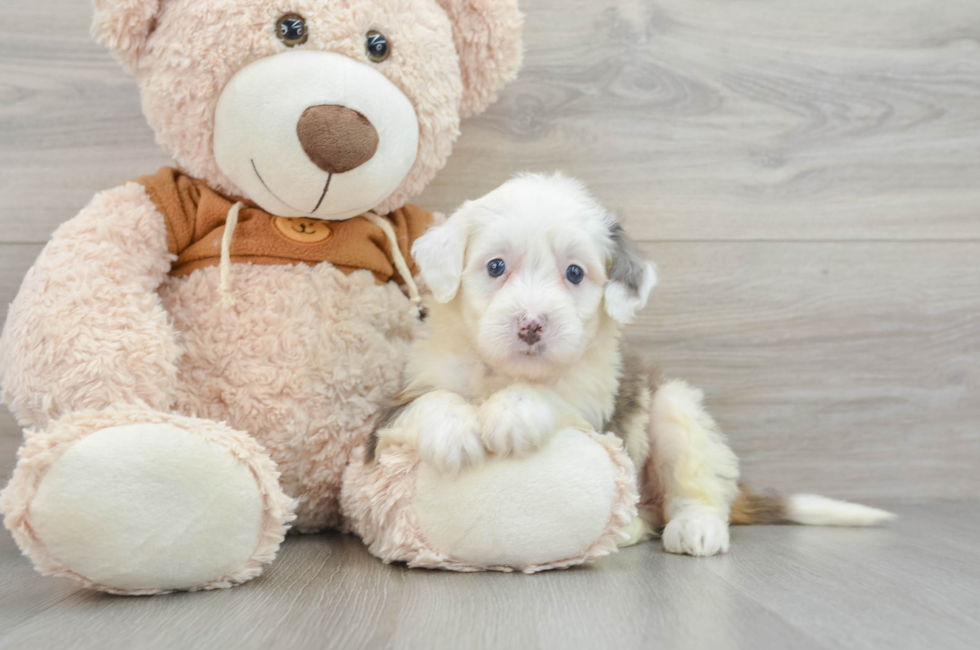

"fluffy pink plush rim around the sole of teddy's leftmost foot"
[0,405,294,594]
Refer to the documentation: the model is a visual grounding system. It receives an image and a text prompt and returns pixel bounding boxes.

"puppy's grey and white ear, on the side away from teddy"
[604,223,657,325]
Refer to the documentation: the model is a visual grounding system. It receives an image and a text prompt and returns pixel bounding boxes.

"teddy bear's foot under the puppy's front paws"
[341,429,637,573]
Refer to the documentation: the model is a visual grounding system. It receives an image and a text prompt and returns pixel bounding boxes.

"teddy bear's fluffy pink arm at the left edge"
[0,183,178,426]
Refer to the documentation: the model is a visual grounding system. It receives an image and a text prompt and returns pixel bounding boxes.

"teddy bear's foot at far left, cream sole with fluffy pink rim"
[0,406,294,594]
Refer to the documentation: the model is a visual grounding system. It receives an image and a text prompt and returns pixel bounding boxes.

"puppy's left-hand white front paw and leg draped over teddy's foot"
[376,390,486,474]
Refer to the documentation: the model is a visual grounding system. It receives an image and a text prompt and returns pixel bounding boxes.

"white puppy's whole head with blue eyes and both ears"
[412,174,657,377]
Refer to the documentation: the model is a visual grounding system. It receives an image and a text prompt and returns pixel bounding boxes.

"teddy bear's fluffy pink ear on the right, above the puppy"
[437,0,524,117]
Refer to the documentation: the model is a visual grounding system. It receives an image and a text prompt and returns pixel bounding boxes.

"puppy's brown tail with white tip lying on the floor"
[731,485,895,526]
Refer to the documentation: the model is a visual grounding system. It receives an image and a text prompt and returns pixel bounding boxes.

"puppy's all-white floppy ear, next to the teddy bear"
[412,209,469,302]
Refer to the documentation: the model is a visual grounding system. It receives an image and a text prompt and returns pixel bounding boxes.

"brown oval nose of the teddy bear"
[296,105,378,174]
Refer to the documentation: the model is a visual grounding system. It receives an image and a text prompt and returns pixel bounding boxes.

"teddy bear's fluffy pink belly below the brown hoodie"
[160,256,417,532]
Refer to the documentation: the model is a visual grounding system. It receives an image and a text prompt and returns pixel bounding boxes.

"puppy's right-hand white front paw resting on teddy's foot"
[480,385,556,455]
